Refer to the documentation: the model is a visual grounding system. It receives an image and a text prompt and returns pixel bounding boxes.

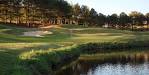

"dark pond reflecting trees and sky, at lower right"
[56,52,149,75]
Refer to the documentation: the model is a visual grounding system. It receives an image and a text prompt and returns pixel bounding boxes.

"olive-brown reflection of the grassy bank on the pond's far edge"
[79,48,149,63]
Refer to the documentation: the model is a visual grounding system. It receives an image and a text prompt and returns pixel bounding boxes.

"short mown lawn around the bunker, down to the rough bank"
[0,25,149,75]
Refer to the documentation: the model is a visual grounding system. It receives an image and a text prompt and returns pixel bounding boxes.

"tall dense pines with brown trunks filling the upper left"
[0,0,72,25]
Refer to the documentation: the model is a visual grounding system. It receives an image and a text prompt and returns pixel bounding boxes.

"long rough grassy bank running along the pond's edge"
[20,41,149,75]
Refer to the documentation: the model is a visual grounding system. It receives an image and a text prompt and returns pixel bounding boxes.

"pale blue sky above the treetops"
[67,0,149,15]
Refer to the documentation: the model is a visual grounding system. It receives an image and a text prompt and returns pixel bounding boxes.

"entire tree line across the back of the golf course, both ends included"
[0,0,149,30]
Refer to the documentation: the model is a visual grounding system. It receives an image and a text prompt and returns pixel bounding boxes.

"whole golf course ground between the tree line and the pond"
[0,24,149,75]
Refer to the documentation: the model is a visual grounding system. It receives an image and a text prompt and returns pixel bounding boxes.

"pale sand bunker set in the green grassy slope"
[23,31,53,37]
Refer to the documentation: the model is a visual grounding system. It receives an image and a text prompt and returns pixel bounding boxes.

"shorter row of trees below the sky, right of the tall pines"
[73,4,149,30]
